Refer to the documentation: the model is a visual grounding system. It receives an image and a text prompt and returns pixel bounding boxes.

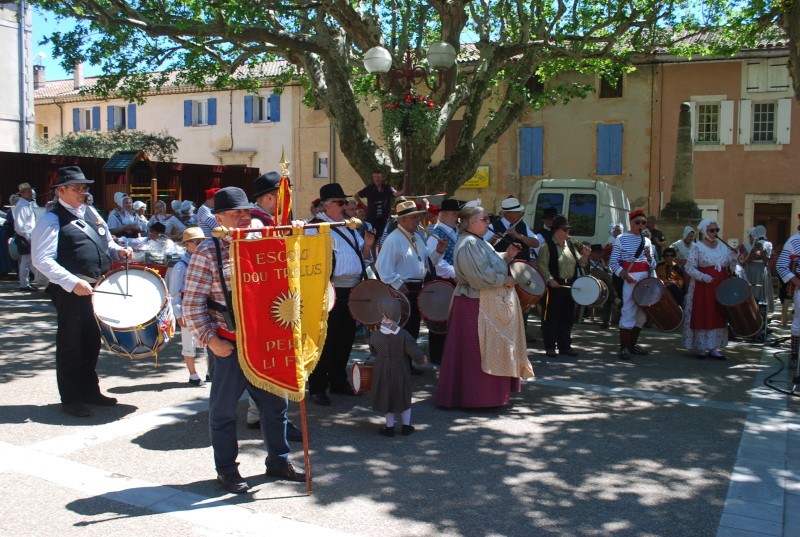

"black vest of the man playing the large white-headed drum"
[53,203,111,279]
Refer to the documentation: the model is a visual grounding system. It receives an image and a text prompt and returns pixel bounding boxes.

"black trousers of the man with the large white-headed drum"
[48,284,100,403]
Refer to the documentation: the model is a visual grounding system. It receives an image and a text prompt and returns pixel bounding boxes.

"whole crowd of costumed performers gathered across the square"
[9,167,800,493]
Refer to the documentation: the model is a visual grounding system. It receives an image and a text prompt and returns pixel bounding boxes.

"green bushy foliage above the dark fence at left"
[37,129,180,162]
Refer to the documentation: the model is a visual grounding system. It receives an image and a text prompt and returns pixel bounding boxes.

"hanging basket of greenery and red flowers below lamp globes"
[381,94,439,146]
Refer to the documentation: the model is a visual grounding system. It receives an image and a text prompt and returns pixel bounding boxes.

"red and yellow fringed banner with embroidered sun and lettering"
[231,225,332,401]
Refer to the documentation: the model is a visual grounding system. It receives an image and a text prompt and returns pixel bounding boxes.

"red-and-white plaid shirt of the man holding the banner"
[183,240,233,345]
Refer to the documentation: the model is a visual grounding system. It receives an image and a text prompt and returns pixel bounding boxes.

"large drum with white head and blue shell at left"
[92,267,175,358]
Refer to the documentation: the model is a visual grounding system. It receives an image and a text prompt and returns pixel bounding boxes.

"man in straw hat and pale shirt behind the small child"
[375,201,447,374]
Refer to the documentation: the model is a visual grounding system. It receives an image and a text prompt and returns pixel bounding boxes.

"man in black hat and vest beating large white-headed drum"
[31,166,131,417]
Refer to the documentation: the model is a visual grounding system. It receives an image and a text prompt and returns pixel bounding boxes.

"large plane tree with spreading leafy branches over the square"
[33,0,764,193]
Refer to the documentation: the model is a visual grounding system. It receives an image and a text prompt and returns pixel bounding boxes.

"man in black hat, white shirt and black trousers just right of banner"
[308,183,375,406]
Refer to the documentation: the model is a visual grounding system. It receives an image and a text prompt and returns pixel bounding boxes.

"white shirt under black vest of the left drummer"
[31,199,124,293]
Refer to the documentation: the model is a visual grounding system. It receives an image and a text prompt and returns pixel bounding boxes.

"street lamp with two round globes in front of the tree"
[364,43,456,195]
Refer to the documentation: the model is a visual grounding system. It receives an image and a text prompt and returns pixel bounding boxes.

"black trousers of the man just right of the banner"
[308,287,356,395]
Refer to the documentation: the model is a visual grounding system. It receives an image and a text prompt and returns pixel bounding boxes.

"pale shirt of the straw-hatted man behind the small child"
[376,226,442,289]
